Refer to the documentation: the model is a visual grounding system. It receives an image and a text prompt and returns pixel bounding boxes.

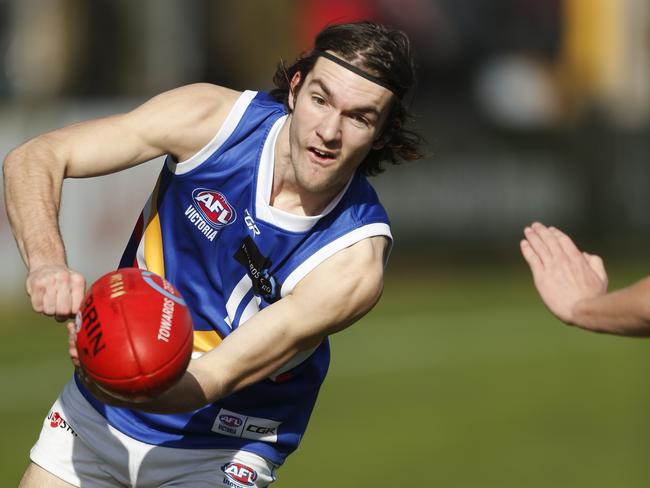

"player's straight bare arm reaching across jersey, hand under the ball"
[80,237,386,413]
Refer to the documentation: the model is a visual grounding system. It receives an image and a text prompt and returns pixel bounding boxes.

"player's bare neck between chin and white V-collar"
[269,115,345,216]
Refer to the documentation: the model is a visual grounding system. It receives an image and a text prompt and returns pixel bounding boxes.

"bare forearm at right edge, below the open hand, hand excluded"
[572,277,650,336]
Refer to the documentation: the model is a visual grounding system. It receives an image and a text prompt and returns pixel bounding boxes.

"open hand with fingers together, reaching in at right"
[520,222,607,325]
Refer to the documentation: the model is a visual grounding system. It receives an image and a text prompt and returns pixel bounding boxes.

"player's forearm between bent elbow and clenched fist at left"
[3,139,65,269]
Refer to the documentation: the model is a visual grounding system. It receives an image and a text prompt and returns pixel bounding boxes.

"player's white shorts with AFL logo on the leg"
[30,380,276,488]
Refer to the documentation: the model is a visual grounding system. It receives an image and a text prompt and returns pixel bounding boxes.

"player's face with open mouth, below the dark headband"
[289,58,393,192]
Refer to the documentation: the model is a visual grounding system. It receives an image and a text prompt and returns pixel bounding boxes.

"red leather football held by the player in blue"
[77,268,193,400]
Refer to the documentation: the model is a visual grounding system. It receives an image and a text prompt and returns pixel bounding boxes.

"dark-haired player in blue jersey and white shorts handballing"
[4,22,420,487]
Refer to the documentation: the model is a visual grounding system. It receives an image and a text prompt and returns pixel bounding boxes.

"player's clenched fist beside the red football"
[25,265,86,322]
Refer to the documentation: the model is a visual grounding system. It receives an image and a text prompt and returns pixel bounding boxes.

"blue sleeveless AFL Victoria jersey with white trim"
[77,91,391,464]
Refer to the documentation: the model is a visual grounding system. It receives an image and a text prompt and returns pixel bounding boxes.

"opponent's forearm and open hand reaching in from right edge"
[521,222,650,336]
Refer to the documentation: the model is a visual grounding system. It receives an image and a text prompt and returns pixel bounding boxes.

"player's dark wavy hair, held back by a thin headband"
[271,21,423,175]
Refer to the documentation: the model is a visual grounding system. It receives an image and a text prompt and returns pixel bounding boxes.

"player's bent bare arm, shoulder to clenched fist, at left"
[3,84,237,318]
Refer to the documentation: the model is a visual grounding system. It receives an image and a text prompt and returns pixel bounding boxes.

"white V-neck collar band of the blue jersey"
[255,115,352,232]
